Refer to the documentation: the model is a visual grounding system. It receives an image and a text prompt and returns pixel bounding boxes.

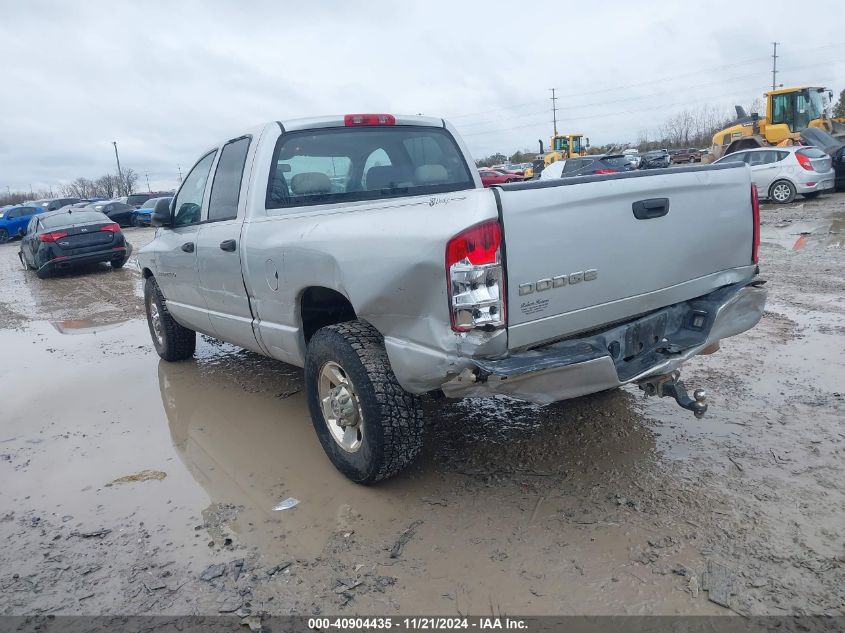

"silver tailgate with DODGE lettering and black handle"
[498,163,755,349]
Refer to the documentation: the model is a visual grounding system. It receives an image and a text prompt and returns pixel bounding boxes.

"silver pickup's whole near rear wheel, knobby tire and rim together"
[305,321,424,484]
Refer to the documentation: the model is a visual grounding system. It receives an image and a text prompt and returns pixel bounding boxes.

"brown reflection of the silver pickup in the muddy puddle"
[158,355,432,555]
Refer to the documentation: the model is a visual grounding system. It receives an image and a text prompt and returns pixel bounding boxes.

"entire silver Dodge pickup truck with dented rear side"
[138,114,766,483]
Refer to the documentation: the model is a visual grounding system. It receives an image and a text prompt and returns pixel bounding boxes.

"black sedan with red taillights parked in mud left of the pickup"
[18,208,132,279]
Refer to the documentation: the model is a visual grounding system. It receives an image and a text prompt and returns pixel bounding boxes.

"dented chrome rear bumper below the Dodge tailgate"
[442,281,767,404]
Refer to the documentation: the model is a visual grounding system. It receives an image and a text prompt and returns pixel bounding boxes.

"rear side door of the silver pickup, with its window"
[197,136,262,352]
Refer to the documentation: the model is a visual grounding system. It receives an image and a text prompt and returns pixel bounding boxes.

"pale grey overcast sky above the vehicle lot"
[0,0,845,191]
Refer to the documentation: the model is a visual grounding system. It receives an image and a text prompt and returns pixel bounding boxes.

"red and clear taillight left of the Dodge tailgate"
[446,220,506,332]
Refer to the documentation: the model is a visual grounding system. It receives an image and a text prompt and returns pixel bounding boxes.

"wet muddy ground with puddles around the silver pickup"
[0,194,845,617]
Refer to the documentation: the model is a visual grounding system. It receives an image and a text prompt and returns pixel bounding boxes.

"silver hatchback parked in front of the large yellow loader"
[715,147,835,204]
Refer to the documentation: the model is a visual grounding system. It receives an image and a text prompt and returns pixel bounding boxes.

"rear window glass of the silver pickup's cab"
[267,126,474,209]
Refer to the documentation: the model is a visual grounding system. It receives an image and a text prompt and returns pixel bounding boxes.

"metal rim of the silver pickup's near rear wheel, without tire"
[317,361,364,453]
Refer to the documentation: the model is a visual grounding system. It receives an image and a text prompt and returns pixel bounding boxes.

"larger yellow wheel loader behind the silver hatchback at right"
[707,86,845,162]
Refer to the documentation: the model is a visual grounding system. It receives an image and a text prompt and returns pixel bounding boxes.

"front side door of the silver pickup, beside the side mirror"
[155,150,217,334]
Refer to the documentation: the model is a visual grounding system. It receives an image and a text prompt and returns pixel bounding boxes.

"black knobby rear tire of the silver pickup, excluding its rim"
[305,321,425,484]
